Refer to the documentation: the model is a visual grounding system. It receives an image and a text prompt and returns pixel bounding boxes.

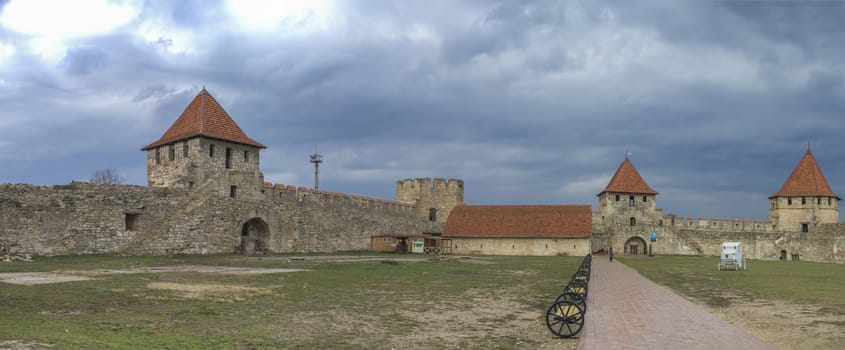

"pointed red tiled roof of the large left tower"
[141,88,266,151]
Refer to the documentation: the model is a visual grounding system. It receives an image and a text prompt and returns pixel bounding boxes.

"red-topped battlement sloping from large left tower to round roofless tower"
[262,182,416,211]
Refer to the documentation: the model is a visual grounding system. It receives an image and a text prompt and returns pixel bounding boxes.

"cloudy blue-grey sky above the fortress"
[0,0,845,219]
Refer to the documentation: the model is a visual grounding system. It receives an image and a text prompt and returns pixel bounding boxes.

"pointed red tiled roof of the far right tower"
[769,148,841,199]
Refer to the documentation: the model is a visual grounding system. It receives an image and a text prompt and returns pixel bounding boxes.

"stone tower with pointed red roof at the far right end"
[769,147,841,232]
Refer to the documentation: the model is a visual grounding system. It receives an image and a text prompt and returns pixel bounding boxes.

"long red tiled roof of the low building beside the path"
[443,205,593,238]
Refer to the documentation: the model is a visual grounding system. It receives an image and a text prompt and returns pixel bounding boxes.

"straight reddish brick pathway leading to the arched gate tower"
[578,255,774,350]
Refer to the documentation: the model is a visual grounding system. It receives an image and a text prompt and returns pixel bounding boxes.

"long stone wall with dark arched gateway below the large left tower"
[0,182,442,255]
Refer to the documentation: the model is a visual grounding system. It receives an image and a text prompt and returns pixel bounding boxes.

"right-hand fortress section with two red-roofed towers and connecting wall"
[591,152,845,262]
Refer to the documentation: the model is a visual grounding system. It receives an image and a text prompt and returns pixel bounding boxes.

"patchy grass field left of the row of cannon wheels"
[0,253,582,349]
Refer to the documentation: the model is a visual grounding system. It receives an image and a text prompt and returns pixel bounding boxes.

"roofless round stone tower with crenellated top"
[396,177,464,223]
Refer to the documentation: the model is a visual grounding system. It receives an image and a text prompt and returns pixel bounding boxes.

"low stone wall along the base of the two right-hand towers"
[591,208,845,262]
